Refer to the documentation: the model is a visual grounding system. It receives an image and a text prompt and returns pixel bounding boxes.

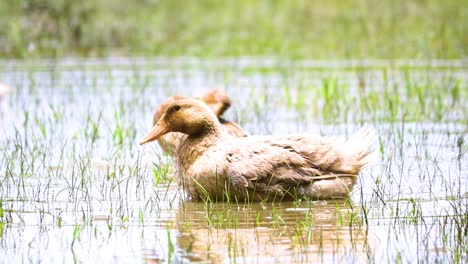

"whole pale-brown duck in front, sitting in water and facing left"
[140,98,377,201]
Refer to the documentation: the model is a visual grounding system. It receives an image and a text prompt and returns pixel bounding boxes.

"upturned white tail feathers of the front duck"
[339,126,379,174]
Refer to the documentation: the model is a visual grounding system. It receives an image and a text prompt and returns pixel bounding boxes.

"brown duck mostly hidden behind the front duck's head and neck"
[153,89,248,155]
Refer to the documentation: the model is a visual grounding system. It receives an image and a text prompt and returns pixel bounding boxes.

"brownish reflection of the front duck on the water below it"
[176,200,370,263]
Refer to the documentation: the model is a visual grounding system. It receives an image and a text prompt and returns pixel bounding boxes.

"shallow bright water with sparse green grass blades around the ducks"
[0,58,468,263]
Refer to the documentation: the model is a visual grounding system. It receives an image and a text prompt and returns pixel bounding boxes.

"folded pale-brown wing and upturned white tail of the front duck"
[221,129,377,192]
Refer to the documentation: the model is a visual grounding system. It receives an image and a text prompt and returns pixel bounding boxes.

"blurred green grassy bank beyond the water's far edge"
[0,0,468,59]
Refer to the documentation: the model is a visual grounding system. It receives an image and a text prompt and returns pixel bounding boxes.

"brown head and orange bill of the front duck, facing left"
[140,98,219,145]
